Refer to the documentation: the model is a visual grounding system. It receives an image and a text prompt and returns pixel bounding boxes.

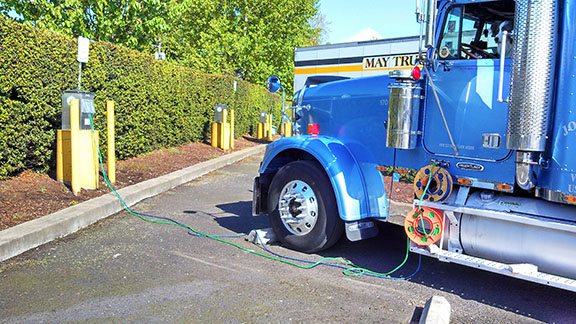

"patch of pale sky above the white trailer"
[320,0,420,44]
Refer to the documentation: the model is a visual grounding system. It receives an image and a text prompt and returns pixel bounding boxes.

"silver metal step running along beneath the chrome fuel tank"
[410,243,576,292]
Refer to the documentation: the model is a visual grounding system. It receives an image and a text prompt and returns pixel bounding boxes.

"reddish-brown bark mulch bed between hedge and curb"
[0,136,266,230]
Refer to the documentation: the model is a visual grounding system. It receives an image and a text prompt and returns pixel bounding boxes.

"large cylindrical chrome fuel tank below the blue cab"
[460,193,576,279]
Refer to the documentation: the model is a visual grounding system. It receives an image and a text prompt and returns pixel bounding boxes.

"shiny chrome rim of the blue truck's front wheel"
[278,180,318,235]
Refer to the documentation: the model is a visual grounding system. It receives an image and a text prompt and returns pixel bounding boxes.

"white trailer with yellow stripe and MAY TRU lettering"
[294,36,419,93]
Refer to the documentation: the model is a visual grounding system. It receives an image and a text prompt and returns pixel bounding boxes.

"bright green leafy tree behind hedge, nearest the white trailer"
[165,0,320,90]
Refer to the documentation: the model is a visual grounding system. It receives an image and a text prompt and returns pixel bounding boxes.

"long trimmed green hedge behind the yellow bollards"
[0,17,281,179]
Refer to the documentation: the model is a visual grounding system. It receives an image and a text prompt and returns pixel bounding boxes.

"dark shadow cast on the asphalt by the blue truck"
[184,201,576,323]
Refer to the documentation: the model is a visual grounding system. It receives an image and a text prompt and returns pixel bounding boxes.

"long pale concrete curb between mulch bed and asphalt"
[0,145,266,261]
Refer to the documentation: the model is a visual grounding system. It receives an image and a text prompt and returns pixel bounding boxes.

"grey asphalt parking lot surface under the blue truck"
[0,156,576,323]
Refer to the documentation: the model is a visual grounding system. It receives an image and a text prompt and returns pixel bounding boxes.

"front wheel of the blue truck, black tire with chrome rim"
[268,161,344,253]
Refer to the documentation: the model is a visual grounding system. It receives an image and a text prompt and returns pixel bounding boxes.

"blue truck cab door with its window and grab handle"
[423,5,513,161]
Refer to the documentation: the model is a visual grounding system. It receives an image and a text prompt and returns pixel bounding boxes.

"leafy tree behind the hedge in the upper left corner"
[0,0,170,50]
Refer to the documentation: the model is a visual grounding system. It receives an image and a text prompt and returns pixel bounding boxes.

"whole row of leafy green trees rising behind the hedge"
[0,0,325,93]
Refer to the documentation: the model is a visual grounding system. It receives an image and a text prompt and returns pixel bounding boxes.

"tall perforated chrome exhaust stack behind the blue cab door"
[506,0,559,190]
